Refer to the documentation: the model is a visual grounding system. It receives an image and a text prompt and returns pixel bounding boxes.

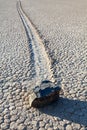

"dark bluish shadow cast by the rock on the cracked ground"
[40,97,87,126]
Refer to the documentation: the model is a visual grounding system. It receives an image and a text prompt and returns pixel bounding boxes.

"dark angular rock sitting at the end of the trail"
[29,80,61,107]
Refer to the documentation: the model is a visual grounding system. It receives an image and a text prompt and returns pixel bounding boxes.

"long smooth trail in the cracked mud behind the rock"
[17,1,54,85]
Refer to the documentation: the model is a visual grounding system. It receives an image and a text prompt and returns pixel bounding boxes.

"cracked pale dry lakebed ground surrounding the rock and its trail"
[0,0,87,130]
